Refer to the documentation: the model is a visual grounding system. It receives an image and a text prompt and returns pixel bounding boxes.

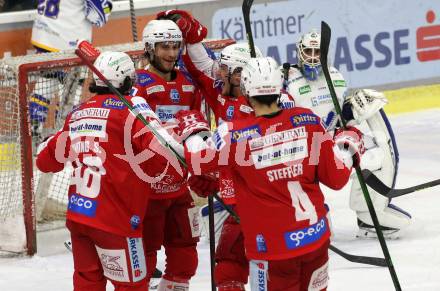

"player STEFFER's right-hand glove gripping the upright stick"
[334,127,365,168]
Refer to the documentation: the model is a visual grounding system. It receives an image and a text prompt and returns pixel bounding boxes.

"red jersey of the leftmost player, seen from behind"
[37,95,181,237]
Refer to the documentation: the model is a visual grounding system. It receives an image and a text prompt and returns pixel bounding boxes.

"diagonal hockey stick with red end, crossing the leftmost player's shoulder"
[75,42,187,167]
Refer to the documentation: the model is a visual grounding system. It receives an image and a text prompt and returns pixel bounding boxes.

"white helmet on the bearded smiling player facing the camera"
[142,19,183,51]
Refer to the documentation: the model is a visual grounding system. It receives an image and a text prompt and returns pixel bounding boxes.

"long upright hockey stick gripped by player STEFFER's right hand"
[319,21,402,291]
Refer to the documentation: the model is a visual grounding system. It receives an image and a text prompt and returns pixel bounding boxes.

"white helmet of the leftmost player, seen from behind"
[93,51,136,88]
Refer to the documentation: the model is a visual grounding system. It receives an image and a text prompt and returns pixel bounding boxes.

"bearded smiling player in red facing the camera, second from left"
[131,20,201,291]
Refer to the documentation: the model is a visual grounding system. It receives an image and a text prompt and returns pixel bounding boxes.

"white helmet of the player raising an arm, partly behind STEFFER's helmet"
[219,42,263,74]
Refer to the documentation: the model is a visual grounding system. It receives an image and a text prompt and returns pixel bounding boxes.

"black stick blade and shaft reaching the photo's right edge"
[362,169,440,198]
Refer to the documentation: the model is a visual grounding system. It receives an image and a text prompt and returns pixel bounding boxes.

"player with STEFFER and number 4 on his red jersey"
[177,58,363,291]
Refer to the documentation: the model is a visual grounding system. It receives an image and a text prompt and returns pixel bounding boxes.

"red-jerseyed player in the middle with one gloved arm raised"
[158,10,262,291]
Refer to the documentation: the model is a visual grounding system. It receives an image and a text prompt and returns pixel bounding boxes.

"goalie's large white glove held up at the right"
[346,89,388,123]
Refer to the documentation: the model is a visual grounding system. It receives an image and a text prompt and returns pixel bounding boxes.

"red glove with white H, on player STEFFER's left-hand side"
[176,110,210,141]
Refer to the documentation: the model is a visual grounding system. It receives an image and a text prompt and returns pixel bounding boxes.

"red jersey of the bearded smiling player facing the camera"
[130,67,201,199]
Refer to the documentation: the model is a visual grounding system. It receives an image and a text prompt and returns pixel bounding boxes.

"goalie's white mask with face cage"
[296,29,322,81]
